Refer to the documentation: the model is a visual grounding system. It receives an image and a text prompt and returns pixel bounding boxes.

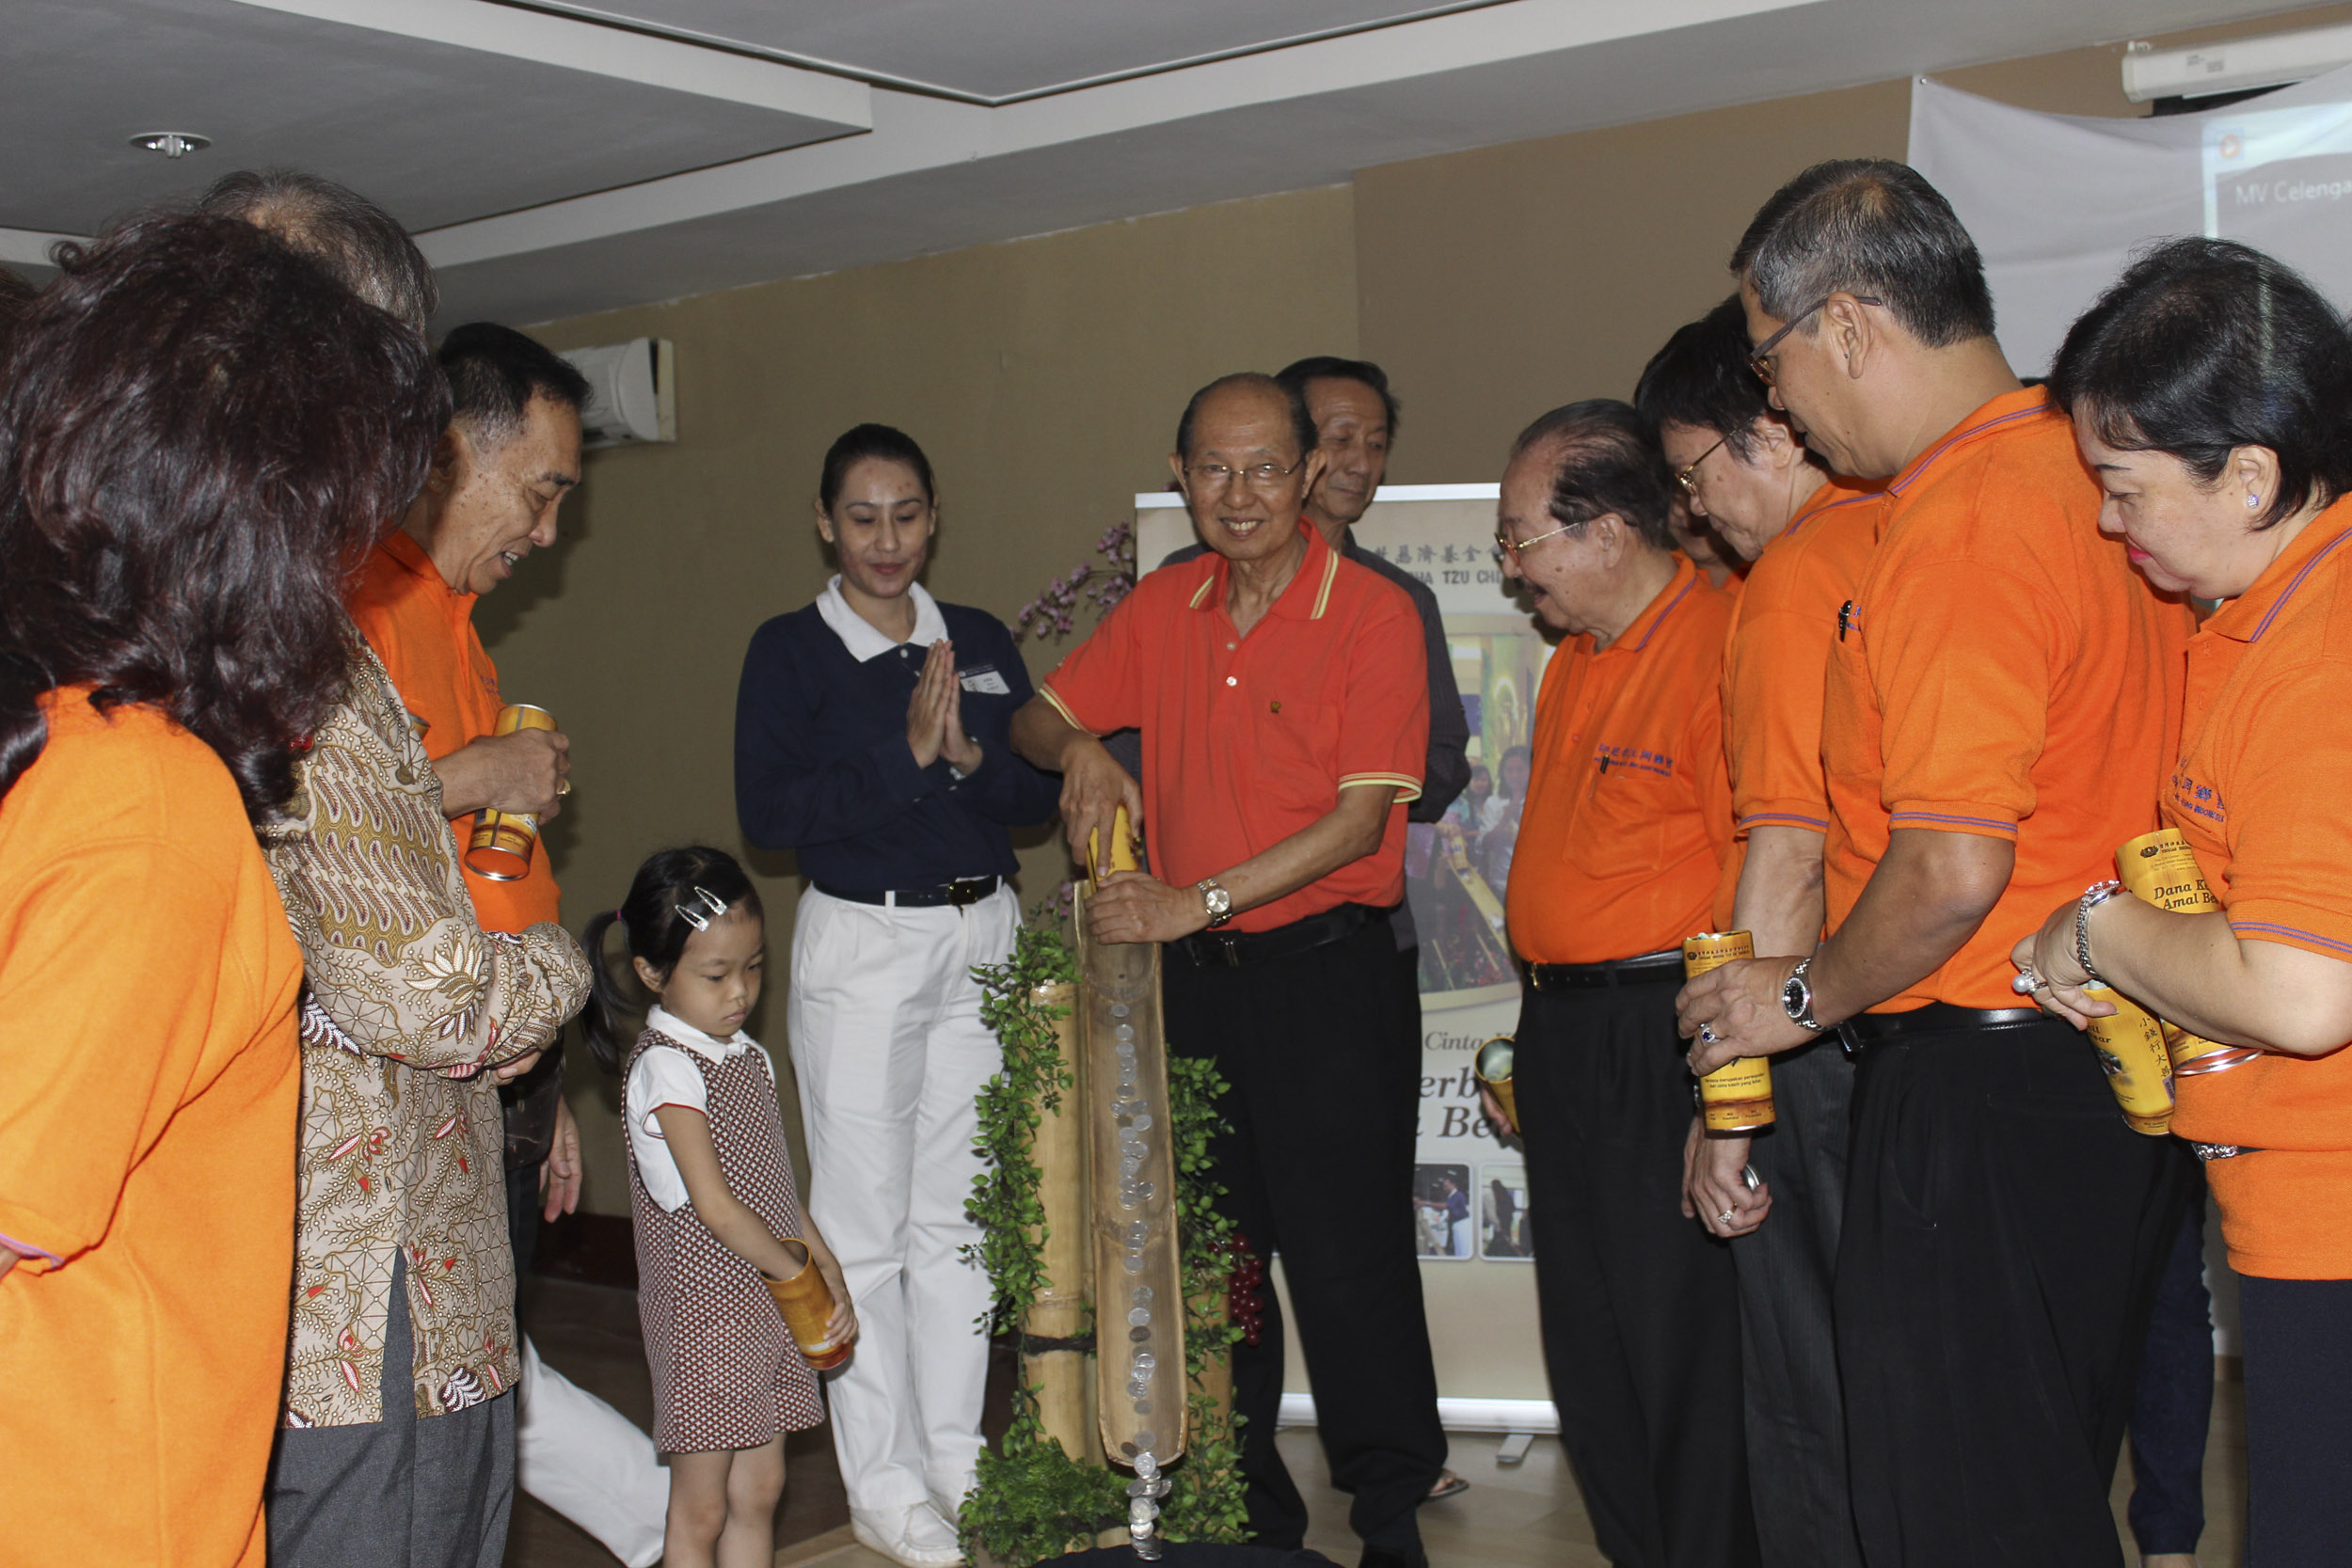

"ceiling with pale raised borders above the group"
[0,0,2314,322]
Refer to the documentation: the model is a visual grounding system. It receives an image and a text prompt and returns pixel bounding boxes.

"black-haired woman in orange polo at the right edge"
[2013,240,2352,1568]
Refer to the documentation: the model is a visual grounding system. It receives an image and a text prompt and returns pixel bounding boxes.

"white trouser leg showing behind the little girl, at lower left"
[516,1338,671,1568]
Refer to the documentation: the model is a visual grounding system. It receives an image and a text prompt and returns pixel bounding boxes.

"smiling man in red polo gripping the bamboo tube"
[1014,373,1447,1568]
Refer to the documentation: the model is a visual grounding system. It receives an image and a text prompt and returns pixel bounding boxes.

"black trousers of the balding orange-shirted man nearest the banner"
[1513,975,1757,1568]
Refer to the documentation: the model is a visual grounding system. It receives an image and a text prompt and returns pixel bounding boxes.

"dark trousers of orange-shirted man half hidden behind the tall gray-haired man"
[1731,1039,1863,1568]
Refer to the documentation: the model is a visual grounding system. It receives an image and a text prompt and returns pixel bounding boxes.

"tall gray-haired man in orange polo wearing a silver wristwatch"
[1675,160,2190,1568]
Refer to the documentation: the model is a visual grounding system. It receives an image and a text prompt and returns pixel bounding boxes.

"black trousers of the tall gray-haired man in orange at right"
[1837,1021,2187,1568]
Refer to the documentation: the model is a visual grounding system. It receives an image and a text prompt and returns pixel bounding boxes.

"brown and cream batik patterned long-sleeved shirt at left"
[263,640,588,1427]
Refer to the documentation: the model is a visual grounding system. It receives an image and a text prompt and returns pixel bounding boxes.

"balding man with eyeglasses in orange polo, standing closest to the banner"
[1489,400,1757,1568]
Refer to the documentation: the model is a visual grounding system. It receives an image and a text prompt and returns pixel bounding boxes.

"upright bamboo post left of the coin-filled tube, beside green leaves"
[1021,983,1104,1465]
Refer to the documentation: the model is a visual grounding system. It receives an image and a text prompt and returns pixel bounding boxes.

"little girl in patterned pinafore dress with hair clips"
[583,848,856,1568]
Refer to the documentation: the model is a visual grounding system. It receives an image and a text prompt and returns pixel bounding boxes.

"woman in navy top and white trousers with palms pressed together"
[737,425,1058,1568]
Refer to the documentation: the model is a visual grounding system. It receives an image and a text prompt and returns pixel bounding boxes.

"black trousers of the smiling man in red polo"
[1162,919,1447,1552]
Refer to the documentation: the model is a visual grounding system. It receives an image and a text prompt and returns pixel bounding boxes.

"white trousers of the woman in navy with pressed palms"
[788,886,1021,1519]
